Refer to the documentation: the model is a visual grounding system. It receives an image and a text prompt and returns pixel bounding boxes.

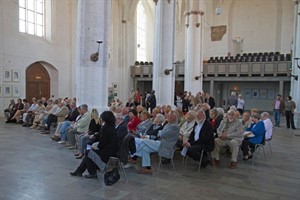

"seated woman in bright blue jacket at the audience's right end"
[241,113,266,160]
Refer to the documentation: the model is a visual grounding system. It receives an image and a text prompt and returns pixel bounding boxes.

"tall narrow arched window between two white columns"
[136,1,147,61]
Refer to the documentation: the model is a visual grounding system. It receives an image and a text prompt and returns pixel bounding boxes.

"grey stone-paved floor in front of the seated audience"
[0,119,300,200]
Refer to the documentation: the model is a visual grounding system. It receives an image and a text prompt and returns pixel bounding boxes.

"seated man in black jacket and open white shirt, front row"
[182,110,215,167]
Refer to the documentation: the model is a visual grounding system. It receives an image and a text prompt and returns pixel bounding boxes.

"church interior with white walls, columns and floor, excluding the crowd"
[0,0,300,200]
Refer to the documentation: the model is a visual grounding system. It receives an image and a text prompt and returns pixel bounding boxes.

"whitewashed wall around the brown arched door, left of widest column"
[0,0,76,115]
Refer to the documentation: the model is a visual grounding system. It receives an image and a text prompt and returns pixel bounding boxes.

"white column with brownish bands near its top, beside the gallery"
[184,0,204,94]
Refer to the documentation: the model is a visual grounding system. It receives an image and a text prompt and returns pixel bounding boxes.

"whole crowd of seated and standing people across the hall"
[4,91,296,178]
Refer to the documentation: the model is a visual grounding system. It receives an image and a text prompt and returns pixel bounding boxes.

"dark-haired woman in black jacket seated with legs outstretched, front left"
[70,111,118,178]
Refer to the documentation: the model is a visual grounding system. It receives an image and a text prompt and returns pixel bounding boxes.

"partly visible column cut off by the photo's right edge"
[291,0,300,129]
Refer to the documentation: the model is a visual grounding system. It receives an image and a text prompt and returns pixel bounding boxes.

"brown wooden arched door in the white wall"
[26,62,50,101]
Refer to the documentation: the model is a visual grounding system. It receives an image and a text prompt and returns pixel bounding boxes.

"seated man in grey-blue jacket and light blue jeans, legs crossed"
[129,110,179,174]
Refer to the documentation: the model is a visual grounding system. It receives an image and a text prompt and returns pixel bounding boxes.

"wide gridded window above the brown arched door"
[19,0,45,37]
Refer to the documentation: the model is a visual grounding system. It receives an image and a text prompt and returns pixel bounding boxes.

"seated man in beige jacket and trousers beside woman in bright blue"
[212,110,243,169]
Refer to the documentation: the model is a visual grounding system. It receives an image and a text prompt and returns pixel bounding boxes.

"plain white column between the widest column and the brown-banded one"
[153,0,175,105]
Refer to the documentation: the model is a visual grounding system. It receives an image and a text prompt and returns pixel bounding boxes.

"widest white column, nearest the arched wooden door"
[76,0,111,113]
